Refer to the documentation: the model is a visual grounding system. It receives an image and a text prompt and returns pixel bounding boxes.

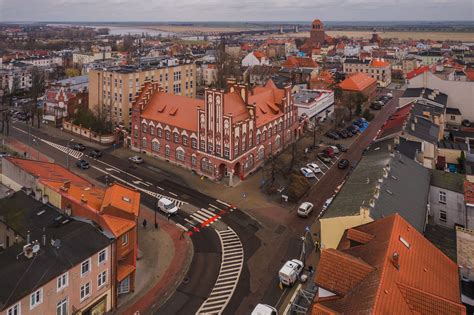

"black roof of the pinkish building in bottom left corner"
[0,191,112,310]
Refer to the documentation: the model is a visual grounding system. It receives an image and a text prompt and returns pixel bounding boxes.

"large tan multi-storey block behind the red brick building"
[89,58,196,128]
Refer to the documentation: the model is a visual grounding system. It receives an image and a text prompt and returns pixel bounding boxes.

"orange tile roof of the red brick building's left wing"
[141,91,204,131]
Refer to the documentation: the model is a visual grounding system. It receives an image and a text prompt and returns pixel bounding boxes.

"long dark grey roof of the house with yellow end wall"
[323,140,430,232]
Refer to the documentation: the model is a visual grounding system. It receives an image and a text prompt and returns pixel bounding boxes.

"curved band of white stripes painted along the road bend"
[196,227,244,315]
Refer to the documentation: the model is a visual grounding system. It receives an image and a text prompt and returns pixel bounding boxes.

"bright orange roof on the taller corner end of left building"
[101,183,140,217]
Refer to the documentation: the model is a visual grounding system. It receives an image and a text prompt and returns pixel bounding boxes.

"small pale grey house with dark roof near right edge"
[429,170,466,228]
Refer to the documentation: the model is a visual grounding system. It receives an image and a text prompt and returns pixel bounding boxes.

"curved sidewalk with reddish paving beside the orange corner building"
[116,205,193,315]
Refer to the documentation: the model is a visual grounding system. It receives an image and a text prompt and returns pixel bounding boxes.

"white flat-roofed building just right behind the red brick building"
[293,90,334,119]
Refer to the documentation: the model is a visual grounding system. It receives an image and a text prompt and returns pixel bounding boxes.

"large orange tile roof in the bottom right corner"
[314,214,466,314]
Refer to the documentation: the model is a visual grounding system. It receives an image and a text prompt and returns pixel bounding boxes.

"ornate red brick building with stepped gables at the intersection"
[130,80,300,181]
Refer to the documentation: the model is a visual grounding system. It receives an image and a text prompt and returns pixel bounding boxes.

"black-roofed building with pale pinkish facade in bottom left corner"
[0,191,114,315]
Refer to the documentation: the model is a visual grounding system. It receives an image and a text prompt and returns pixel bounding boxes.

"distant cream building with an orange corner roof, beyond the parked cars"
[343,59,392,87]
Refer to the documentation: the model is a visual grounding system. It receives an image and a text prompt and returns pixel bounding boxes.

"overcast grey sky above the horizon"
[0,0,474,22]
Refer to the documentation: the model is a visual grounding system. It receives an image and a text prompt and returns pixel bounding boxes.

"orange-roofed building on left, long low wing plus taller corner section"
[2,157,140,307]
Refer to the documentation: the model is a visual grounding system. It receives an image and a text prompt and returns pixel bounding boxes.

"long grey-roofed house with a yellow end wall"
[319,139,430,248]
